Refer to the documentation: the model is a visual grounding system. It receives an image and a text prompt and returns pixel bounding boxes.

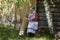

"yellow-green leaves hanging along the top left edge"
[0,0,30,8]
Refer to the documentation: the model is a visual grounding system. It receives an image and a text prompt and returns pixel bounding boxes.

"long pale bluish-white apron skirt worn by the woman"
[27,11,38,34]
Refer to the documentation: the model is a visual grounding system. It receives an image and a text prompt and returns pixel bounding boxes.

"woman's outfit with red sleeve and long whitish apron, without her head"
[27,13,38,34]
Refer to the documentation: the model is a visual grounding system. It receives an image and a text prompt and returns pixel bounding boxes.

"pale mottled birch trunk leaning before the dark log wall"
[44,1,53,33]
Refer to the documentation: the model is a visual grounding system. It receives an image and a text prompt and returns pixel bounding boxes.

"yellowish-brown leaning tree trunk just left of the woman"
[19,2,29,35]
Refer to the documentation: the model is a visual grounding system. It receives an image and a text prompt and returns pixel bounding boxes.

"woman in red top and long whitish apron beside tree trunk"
[26,7,38,37]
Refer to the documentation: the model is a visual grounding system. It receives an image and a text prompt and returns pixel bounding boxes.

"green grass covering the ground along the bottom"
[0,26,53,40]
